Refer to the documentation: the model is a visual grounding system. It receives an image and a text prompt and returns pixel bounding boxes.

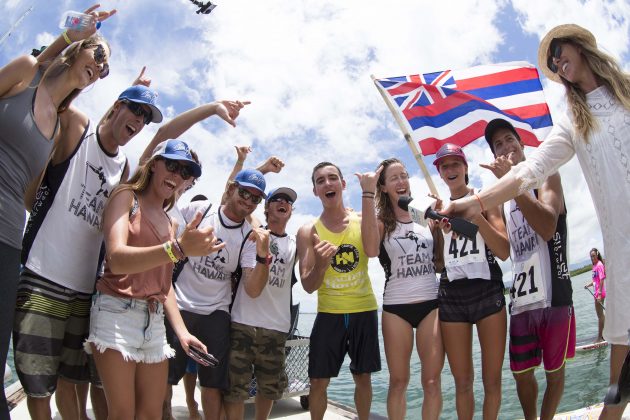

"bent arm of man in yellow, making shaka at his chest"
[297,224,337,293]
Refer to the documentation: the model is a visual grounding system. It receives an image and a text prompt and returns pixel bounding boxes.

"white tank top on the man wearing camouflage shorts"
[232,233,296,333]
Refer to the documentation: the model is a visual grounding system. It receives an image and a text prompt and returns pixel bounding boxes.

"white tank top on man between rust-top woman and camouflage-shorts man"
[175,201,256,315]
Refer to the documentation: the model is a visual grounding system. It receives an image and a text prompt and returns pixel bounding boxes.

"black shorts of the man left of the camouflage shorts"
[166,311,230,390]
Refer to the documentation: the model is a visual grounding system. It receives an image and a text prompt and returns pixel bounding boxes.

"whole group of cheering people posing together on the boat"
[0,7,630,419]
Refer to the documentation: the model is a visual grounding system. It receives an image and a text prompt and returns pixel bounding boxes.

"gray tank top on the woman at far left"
[0,69,59,249]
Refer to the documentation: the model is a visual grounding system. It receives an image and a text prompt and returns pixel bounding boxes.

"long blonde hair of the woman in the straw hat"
[560,37,630,143]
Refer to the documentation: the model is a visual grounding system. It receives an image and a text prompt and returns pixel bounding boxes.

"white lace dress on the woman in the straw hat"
[513,86,630,345]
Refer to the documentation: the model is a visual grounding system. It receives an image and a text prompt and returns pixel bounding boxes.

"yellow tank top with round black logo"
[315,213,377,314]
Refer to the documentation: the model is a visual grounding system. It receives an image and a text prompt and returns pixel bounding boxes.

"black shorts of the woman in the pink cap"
[438,279,505,324]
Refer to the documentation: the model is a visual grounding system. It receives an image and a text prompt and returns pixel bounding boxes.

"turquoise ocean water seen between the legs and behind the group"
[298,272,610,419]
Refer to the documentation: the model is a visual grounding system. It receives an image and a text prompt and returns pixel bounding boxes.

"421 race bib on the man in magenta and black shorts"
[510,252,547,308]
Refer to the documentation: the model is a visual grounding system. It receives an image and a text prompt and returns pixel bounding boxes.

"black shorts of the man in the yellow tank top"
[308,311,381,378]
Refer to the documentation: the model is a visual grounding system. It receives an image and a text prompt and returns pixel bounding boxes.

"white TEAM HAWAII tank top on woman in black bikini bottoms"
[378,222,439,305]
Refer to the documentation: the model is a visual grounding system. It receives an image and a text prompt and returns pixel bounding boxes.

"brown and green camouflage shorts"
[225,322,287,402]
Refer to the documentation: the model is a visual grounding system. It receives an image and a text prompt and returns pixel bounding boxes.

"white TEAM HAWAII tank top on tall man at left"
[22,124,127,293]
